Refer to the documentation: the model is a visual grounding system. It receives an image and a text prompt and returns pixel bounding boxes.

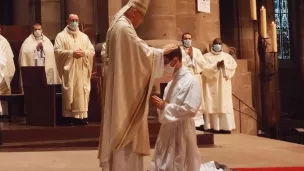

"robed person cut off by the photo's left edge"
[0,26,15,115]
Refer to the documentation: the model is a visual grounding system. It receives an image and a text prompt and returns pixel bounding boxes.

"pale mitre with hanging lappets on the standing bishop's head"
[109,0,150,29]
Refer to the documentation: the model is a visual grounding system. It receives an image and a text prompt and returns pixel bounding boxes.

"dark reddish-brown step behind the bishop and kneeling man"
[0,119,214,149]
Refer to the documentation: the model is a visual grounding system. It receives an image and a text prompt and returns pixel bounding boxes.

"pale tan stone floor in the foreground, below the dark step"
[0,134,304,171]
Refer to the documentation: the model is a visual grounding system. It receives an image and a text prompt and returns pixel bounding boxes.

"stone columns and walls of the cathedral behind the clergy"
[0,0,304,142]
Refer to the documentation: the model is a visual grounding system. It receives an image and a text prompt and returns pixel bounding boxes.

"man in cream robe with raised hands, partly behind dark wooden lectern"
[19,24,60,87]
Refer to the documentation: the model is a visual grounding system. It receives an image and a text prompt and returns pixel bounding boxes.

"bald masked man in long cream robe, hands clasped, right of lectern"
[54,14,95,125]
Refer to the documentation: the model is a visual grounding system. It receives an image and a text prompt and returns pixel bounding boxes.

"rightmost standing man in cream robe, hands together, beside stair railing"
[198,38,237,133]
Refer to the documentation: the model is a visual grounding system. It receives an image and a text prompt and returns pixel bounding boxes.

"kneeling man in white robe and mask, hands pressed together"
[150,48,229,171]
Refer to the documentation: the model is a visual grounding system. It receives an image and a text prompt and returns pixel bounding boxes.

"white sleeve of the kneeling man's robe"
[159,80,201,123]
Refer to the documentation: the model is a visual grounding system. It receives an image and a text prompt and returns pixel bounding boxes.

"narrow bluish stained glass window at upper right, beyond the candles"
[274,0,290,60]
